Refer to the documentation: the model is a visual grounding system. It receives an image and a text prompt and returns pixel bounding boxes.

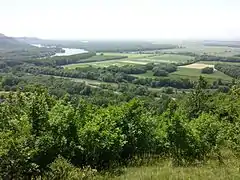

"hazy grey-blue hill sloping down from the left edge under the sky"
[0,33,31,50]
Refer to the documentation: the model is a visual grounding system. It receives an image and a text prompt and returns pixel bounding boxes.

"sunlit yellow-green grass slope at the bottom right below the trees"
[95,150,240,180]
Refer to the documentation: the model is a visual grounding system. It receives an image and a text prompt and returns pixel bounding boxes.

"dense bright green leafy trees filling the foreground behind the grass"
[0,78,240,179]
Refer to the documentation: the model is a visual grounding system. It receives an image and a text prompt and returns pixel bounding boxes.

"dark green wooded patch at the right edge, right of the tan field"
[215,64,240,79]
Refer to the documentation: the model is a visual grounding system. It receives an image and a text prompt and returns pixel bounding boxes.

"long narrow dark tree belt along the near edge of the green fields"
[15,65,194,89]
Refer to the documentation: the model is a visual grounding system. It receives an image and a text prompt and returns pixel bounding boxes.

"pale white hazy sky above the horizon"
[0,0,240,39]
